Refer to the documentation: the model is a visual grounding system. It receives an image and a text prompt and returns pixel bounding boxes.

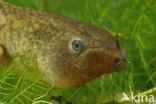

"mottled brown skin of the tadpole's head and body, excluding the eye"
[0,2,125,88]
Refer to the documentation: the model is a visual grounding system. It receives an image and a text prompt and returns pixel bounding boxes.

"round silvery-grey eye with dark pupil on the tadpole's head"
[69,38,85,54]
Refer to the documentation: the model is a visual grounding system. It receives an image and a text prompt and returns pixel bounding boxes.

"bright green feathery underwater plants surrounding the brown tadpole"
[0,0,156,104]
